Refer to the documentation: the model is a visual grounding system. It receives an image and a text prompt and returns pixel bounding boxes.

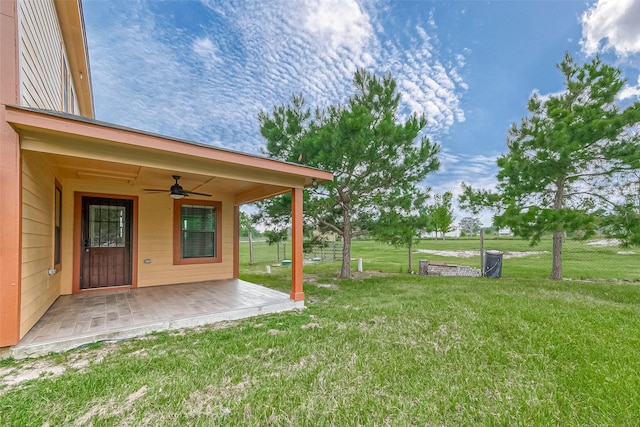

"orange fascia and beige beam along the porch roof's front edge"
[5,105,333,193]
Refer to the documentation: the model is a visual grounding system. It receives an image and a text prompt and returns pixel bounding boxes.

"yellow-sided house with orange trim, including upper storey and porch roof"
[0,0,332,348]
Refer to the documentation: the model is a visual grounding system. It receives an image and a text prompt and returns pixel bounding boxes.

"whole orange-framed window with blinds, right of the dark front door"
[173,199,222,264]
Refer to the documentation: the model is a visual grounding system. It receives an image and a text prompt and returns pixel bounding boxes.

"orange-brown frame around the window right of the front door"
[173,199,222,265]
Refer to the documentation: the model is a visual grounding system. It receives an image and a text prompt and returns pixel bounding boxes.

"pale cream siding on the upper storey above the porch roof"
[19,0,63,110]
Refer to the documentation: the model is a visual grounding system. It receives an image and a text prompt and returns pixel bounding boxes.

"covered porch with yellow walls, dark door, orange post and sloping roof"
[0,106,332,354]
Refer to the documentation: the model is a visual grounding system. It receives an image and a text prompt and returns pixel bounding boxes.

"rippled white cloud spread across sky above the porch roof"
[84,0,467,153]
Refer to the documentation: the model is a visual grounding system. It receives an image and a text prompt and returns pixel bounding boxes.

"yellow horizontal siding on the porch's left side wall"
[20,152,60,336]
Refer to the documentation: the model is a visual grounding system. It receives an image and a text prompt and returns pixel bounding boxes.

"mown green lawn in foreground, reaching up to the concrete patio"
[0,260,640,426]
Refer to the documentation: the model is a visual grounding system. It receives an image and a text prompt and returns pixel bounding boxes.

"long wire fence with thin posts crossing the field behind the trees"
[240,233,640,281]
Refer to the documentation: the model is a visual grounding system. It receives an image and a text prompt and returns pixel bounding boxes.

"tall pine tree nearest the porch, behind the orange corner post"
[258,69,440,278]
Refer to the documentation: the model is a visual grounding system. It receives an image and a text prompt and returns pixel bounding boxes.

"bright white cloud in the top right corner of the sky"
[581,0,640,56]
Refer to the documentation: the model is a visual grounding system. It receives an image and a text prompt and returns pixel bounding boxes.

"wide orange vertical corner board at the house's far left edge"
[0,1,22,347]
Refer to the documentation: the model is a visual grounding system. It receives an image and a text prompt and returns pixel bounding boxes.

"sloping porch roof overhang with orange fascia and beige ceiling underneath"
[5,106,333,204]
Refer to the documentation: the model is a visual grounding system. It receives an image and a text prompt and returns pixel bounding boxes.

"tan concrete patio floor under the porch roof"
[11,279,304,359]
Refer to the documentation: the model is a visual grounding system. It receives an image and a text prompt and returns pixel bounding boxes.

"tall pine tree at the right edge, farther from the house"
[460,53,640,279]
